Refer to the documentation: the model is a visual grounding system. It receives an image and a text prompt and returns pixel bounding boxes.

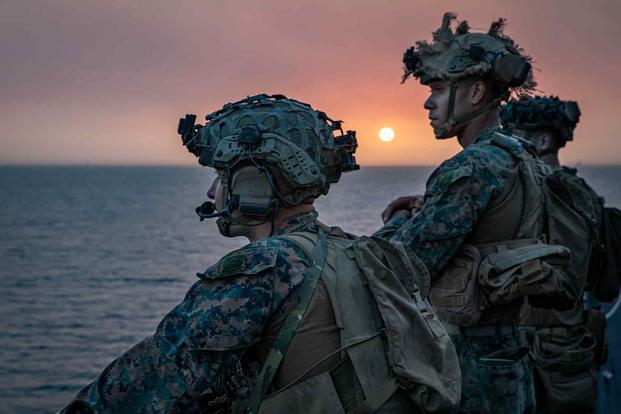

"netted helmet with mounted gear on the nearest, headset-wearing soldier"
[178,94,359,196]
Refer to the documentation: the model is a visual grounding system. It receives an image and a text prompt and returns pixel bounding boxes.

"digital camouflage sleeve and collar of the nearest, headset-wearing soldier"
[62,212,319,414]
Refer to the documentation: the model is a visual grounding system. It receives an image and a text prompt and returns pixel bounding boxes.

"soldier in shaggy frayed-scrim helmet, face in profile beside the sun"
[376,13,577,413]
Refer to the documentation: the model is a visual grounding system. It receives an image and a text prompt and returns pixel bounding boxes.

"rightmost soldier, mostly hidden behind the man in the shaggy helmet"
[501,96,619,413]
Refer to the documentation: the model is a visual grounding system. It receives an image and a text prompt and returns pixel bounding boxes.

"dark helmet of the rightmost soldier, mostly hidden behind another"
[500,96,580,141]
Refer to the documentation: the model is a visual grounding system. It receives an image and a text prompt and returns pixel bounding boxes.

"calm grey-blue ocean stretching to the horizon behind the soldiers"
[0,166,621,414]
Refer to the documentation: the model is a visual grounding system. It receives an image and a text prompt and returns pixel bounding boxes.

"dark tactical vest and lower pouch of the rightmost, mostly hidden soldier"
[520,168,609,414]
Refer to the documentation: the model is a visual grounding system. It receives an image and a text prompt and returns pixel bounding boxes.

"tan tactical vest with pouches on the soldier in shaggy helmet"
[430,132,583,326]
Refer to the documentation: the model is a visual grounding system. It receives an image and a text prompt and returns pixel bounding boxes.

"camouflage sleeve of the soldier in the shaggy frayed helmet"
[375,130,515,278]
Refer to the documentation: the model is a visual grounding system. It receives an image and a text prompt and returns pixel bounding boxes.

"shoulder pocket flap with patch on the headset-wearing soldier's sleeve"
[197,246,278,279]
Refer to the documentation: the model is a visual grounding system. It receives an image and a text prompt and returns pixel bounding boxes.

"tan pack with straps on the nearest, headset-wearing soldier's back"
[248,228,461,413]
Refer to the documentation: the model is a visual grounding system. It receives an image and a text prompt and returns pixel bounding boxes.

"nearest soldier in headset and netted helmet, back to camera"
[62,95,460,413]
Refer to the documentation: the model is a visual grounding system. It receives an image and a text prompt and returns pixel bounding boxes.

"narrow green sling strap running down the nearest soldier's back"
[248,228,328,414]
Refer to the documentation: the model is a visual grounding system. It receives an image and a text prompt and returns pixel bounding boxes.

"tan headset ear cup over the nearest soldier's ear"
[231,166,278,218]
